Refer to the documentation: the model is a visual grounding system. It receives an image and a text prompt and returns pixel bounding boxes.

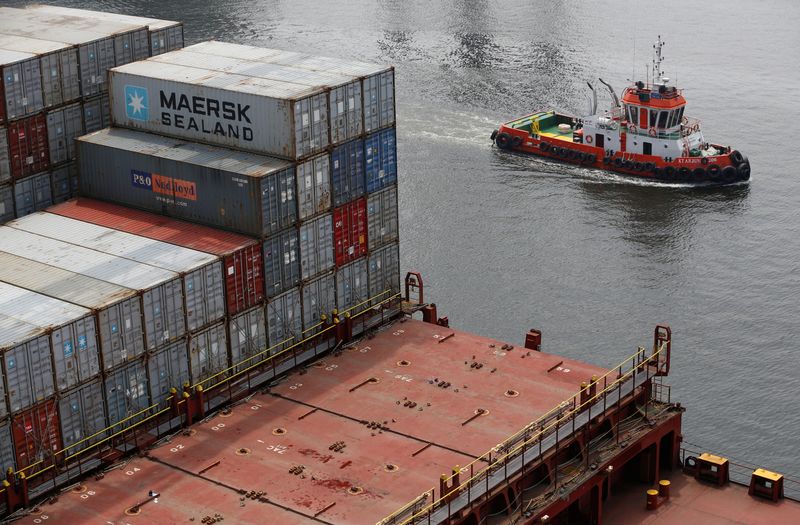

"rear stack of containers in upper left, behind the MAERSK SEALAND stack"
[0,5,183,224]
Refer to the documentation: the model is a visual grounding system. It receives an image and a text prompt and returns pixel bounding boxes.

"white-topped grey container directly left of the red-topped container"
[8,213,225,330]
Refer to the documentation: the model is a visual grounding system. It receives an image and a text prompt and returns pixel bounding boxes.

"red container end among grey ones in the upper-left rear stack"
[8,113,50,179]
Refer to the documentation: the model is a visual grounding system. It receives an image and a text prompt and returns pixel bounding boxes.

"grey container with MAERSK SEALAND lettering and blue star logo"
[110,60,330,160]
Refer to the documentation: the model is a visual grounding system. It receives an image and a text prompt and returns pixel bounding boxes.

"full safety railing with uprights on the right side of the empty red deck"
[378,341,669,525]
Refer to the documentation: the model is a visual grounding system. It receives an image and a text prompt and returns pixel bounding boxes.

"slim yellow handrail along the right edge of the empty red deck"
[378,342,667,525]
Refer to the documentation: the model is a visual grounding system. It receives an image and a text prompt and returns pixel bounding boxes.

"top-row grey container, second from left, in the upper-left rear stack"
[0,34,81,107]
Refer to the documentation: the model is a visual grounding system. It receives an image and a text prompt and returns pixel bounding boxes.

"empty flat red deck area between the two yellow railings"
[10,320,604,525]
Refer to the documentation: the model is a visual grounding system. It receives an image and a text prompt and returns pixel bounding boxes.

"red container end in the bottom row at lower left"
[11,399,61,476]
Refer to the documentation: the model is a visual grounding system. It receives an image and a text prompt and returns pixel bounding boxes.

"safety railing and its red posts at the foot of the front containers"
[0,290,401,506]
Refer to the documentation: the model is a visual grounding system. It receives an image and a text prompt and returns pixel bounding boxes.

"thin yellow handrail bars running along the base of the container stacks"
[5,289,401,486]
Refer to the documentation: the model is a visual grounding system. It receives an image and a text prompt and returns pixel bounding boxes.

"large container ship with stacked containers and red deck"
[0,6,800,525]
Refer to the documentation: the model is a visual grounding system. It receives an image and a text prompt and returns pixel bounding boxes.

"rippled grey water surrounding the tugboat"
[6,0,800,475]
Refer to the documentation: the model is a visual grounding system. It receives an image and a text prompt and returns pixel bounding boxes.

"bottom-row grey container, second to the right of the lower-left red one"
[103,359,150,432]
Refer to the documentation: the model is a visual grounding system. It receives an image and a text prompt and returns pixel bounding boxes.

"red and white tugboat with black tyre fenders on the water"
[491,35,750,184]
